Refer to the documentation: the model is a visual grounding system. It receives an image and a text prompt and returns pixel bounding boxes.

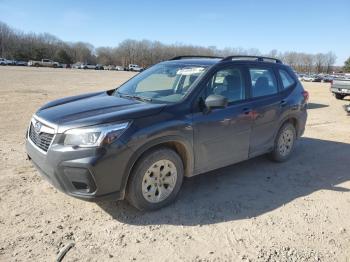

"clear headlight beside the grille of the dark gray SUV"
[63,122,129,147]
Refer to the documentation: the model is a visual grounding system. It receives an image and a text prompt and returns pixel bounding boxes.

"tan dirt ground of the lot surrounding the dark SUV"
[0,67,350,261]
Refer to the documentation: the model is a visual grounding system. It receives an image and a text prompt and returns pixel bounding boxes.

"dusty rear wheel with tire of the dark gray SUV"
[269,123,296,162]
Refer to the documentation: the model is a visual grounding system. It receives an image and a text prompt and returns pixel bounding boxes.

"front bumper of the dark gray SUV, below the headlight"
[26,136,132,200]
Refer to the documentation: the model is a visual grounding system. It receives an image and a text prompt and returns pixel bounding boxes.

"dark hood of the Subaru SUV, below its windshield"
[36,92,165,130]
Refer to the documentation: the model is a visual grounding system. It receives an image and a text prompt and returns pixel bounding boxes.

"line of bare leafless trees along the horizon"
[0,21,344,73]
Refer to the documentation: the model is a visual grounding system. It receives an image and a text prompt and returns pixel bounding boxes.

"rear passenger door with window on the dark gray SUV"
[248,66,283,157]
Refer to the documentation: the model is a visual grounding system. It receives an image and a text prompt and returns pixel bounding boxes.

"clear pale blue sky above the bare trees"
[0,0,350,65]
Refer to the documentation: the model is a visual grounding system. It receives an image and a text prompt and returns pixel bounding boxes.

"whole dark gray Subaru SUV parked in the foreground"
[26,56,308,210]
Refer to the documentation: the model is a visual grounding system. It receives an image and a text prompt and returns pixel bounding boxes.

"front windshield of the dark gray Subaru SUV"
[114,64,206,103]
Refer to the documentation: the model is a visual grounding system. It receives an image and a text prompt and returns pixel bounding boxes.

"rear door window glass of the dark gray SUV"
[249,68,278,97]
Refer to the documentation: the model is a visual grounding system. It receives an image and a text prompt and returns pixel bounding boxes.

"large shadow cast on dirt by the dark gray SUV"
[98,138,350,225]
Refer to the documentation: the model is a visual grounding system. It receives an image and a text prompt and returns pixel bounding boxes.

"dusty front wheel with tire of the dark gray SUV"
[126,147,184,211]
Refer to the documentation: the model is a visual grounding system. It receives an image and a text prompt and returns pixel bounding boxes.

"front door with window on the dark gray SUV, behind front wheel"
[193,65,252,173]
